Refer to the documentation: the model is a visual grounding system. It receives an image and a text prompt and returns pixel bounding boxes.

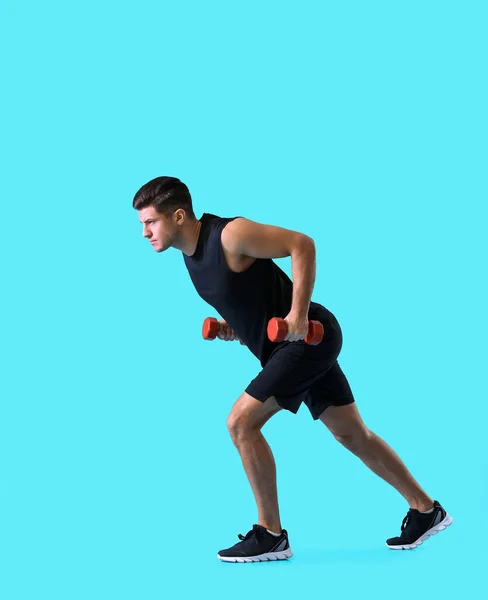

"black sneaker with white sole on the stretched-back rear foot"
[386,500,452,550]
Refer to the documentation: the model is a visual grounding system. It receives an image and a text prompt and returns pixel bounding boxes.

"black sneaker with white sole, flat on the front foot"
[217,525,293,562]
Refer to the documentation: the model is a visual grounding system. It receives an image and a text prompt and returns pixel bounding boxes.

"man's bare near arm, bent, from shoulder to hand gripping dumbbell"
[222,218,316,341]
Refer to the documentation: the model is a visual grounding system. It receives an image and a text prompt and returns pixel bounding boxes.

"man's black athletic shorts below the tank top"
[246,308,354,420]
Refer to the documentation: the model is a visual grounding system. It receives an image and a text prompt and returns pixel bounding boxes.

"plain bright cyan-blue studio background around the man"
[0,0,488,600]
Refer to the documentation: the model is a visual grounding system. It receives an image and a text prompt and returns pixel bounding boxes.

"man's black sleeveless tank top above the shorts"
[182,213,328,366]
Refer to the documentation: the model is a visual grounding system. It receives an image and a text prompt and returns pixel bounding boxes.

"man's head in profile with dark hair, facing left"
[132,177,195,252]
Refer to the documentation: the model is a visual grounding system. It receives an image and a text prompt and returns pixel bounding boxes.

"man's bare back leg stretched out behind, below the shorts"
[320,403,434,511]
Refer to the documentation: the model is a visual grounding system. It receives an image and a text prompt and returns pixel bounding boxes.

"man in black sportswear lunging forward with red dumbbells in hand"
[133,177,452,562]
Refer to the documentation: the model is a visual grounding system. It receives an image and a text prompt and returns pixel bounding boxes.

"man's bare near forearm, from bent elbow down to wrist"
[290,236,315,318]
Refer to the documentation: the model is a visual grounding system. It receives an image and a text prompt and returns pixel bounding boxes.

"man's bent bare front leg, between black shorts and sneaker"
[227,392,282,533]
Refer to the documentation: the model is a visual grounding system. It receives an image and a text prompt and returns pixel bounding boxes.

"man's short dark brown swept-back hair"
[132,177,195,219]
